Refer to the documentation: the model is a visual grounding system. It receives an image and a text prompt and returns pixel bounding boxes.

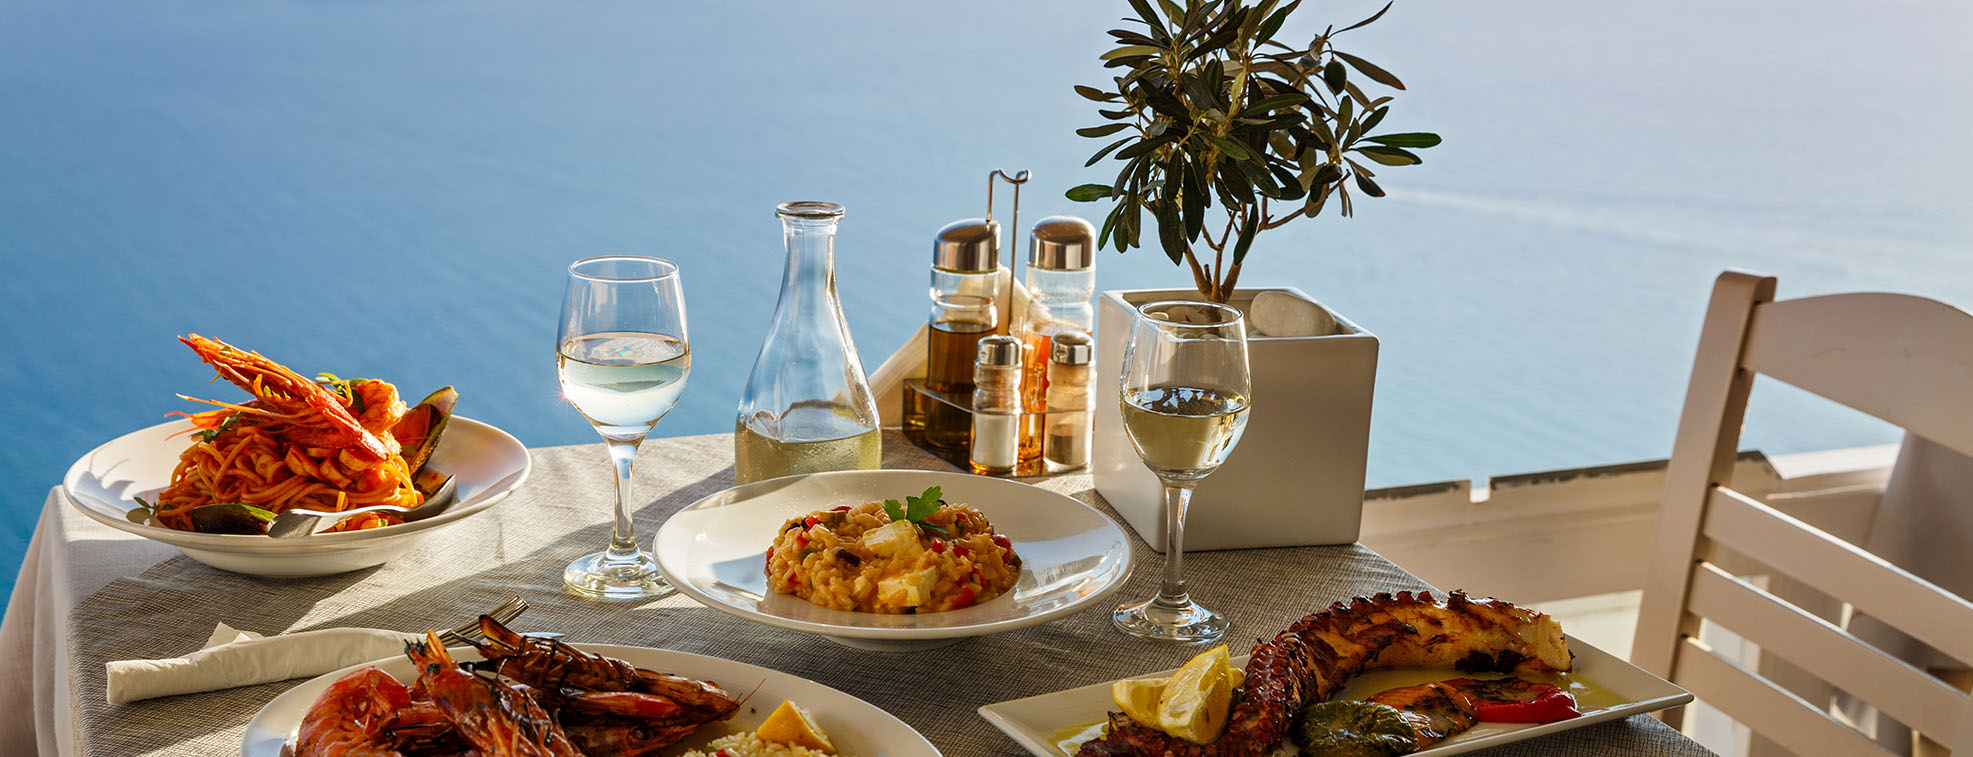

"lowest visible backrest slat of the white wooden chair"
[1671,639,1896,757]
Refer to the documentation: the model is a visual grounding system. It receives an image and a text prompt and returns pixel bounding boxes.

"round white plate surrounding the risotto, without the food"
[655,471,1131,651]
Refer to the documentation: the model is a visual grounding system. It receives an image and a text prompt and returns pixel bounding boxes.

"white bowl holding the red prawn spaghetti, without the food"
[61,416,529,578]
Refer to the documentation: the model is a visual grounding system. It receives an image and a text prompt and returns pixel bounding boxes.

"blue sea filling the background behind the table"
[0,0,1973,603]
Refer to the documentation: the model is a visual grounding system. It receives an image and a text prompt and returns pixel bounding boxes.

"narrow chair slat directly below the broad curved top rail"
[1703,487,1973,664]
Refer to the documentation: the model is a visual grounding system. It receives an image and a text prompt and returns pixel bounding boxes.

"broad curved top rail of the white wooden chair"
[1740,292,1973,455]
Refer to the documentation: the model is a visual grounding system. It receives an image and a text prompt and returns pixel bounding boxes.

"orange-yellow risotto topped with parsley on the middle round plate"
[767,487,1020,613]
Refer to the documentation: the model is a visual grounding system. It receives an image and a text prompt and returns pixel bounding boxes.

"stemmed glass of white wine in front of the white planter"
[1111,302,1253,643]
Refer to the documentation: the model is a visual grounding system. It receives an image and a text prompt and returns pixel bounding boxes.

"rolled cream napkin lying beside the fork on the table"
[105,623,424,704]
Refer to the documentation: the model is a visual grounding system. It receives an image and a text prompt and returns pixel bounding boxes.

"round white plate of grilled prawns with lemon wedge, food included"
[241,615,939,757]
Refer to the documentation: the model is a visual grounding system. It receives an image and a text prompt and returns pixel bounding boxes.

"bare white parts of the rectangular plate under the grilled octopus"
[981,639,1693,757]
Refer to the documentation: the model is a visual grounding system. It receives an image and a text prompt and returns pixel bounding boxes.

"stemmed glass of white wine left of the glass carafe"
[554,254,693,601]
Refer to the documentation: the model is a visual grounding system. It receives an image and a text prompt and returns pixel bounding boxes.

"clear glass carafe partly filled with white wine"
[734,203,879,483]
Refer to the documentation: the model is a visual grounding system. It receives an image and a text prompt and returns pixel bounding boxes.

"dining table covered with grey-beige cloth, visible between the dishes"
[0,432,1711,757]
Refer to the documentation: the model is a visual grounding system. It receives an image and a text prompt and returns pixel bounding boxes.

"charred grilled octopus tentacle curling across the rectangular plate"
[1077,591,1571,757]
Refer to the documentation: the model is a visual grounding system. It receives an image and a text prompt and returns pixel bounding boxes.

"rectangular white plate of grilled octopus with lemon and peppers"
[979,591,1693,757]
